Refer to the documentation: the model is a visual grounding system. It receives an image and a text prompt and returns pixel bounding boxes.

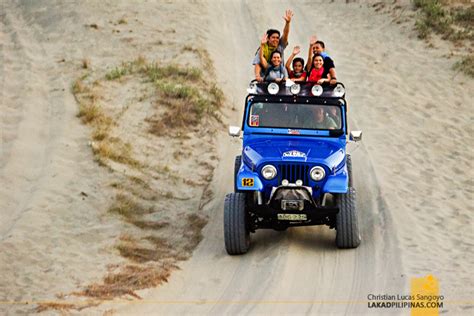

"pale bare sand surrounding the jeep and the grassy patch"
[0,0,474,315]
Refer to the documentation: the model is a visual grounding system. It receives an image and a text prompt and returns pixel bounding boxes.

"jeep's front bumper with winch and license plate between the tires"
[254,183,339,228]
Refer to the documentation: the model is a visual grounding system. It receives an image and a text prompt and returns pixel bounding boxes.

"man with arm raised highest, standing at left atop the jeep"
[252,10,293,82]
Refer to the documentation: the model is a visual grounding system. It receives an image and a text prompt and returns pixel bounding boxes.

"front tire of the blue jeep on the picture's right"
[336,187,360,248]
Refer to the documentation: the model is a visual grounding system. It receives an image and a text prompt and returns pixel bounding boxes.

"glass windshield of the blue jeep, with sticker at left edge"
[247,102,342,130]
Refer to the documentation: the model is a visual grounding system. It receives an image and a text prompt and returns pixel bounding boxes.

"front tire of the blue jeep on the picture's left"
[224,193,250,255]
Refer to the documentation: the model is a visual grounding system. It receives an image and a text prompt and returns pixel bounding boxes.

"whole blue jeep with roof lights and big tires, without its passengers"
[224,82,362,255]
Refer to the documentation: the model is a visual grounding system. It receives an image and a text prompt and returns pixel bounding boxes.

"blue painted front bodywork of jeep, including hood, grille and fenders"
[236,95,348,198]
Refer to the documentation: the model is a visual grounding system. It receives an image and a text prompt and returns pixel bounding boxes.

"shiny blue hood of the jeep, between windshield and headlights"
[243,137,345,170]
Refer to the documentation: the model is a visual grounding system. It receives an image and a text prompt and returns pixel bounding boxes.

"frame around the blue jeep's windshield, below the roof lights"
[242,95,347,137]
